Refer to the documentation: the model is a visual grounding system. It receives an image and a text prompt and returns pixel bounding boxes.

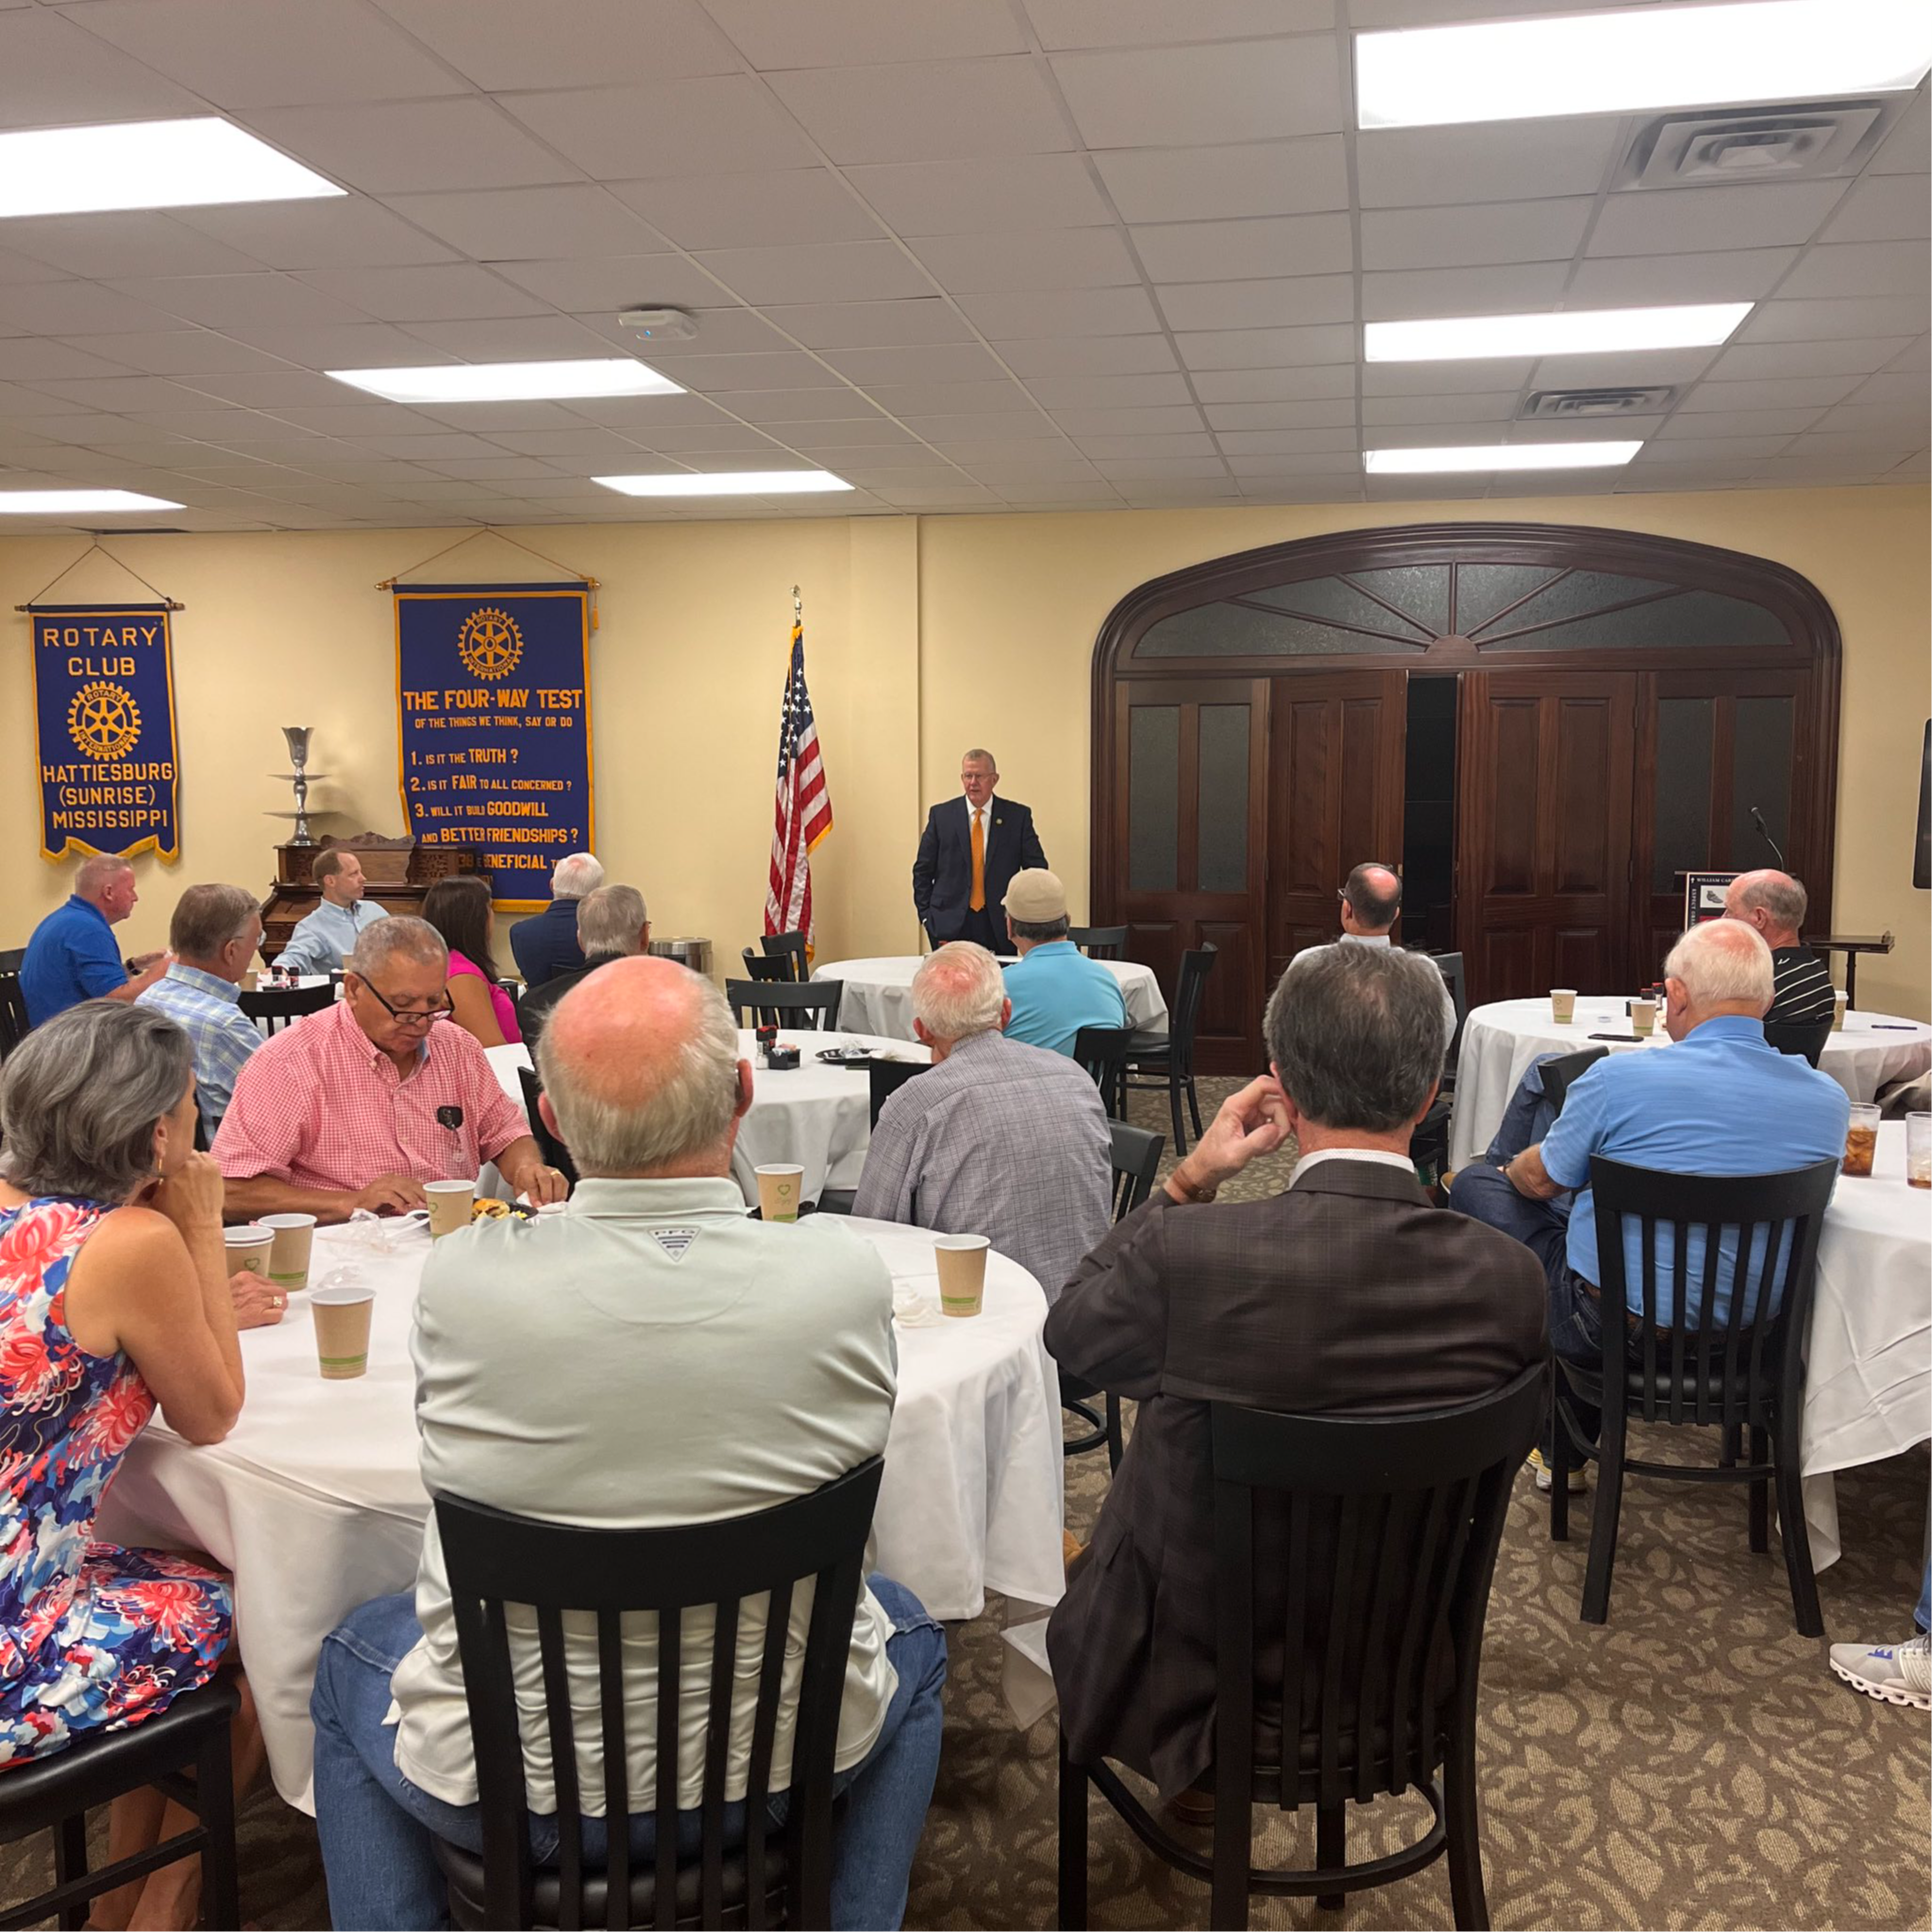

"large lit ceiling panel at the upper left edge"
[0,116,347,216]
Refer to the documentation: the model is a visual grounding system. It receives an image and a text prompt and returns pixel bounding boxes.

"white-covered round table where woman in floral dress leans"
[98,1219,1065,1810]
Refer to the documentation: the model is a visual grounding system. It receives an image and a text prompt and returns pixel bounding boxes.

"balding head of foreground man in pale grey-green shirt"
[537,956,751,1179]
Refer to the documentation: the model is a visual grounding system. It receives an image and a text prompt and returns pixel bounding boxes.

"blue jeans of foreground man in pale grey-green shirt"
[310,1576,947,1932]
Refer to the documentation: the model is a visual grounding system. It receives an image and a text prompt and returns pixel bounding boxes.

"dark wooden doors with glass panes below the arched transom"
[1115,666,1822,1072]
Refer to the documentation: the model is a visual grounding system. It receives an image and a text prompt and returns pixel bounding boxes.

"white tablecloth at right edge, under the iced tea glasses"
[1799,1120,1932,1569]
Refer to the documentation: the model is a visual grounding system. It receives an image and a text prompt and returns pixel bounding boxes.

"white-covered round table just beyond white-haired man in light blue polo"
[1449,993,1932,1167]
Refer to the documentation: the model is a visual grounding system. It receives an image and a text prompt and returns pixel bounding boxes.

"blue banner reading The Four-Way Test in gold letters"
[396,583,597,912]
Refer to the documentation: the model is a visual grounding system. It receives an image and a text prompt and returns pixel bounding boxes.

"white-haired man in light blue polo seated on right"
[1449,919,1851,1364]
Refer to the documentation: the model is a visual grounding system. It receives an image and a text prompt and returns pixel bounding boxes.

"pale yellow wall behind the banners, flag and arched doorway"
[0,487,1932,1015]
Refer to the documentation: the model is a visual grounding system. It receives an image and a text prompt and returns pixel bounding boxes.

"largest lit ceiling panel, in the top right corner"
[1354,0,1932,127]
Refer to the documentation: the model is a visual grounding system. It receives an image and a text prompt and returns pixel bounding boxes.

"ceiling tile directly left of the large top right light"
[1051,35,1343,149]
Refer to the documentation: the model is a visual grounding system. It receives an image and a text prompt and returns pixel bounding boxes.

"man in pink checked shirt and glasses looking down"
[214,917,568,1223]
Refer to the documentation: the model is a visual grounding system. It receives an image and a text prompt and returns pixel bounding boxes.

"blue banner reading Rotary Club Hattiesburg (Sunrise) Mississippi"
[29,605,181,860]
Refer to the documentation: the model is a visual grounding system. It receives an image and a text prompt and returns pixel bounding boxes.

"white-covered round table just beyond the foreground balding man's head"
[485,1030,932,1205]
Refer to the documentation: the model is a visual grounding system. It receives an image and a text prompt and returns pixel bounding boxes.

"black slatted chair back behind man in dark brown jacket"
[1209,1364,1548,1808]
